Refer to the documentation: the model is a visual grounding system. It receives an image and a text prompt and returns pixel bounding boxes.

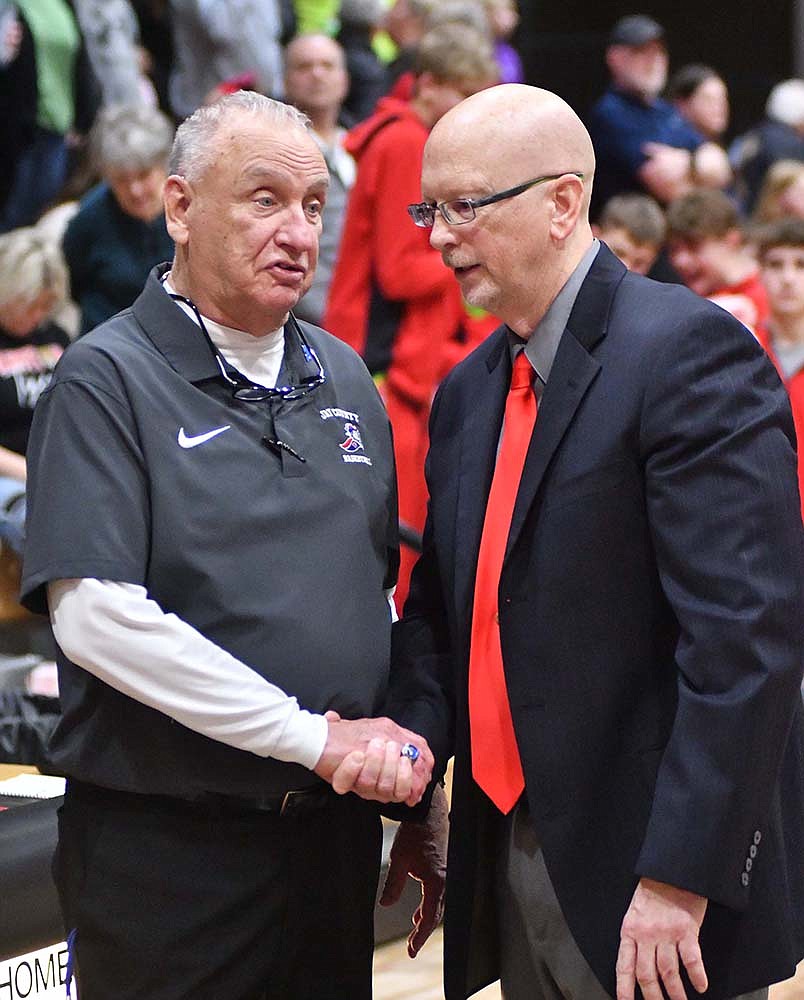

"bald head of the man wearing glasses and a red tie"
[422,84,595,336]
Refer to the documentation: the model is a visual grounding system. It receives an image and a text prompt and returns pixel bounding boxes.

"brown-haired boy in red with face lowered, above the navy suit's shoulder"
[667,188,768,330]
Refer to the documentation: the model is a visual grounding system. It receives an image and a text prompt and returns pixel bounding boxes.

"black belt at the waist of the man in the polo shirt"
[67,778,337,817]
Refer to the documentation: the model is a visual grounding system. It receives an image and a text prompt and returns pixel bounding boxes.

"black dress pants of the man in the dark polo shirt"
[54,785,381,1000]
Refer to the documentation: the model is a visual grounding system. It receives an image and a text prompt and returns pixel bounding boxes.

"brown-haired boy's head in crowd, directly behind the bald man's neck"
[592,194,666,274]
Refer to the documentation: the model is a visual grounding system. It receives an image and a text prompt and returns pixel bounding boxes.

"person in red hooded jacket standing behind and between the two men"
[323,24,497,607]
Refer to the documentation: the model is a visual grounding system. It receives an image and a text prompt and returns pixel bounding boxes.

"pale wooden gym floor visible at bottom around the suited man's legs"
[374,930,804,1000]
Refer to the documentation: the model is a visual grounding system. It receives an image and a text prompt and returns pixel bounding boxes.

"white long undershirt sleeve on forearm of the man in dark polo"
[47,579,327,769]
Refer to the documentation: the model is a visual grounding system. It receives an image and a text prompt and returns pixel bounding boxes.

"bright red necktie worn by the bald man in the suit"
[469,351,536,813]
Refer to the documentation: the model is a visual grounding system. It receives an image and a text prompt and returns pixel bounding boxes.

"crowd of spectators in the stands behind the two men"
[0,0,804,744]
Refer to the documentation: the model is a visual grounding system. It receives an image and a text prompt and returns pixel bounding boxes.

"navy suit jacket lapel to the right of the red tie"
[506,245,627,557]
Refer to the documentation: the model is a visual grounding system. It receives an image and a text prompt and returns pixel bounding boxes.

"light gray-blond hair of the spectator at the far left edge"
[0,226,67,307]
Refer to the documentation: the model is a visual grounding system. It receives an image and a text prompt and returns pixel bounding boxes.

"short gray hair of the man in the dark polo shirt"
[168,90,310,181]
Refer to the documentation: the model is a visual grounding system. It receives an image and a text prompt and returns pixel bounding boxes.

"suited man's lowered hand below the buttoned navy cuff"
[617,878,708,1000]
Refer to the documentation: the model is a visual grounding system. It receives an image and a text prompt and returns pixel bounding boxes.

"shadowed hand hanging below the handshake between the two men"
[380,785,449,958]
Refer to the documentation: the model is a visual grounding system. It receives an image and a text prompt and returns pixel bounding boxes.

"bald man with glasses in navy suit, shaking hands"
[344,85,804,1000]
